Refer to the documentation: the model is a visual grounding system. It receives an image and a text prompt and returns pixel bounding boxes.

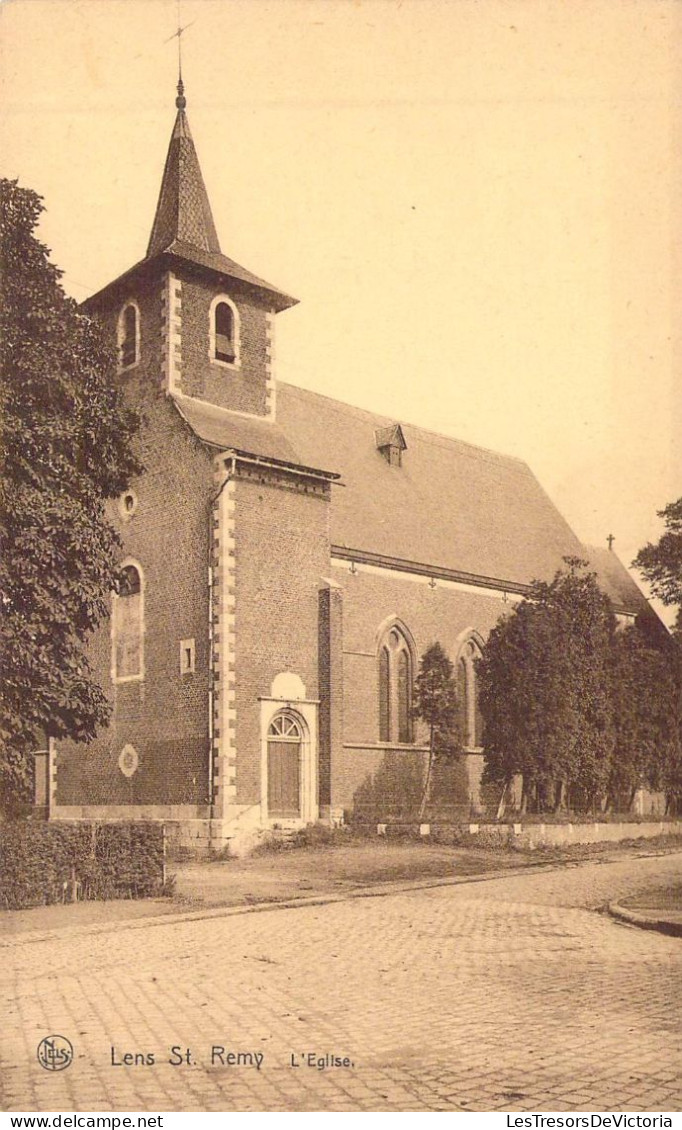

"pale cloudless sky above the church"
[0,0,682,622]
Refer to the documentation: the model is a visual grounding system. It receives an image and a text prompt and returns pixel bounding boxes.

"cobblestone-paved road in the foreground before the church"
[0,854,682,1112]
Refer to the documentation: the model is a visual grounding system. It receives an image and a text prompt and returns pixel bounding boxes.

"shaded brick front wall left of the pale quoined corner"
[56,280,212,805]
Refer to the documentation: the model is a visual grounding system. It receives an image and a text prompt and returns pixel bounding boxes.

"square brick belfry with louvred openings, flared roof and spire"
[85,78,296,421]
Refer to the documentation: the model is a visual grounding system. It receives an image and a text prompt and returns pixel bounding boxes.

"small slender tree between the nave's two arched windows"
[413,643,461,819]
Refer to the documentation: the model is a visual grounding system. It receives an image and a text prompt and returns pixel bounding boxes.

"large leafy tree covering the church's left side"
[0,180,142,808]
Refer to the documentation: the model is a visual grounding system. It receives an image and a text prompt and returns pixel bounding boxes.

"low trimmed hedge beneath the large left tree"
[0,819,164,910]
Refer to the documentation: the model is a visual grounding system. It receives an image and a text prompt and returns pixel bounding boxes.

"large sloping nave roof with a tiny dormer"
[278,383,600,584]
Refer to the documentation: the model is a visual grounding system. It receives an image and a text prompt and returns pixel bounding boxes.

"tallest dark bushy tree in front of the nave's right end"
[478,557,615,811]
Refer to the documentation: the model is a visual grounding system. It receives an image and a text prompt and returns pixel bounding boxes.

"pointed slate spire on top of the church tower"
[147,80,220,259]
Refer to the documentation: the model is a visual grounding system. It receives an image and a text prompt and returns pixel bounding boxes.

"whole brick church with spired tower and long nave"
[50,81,647,850]
